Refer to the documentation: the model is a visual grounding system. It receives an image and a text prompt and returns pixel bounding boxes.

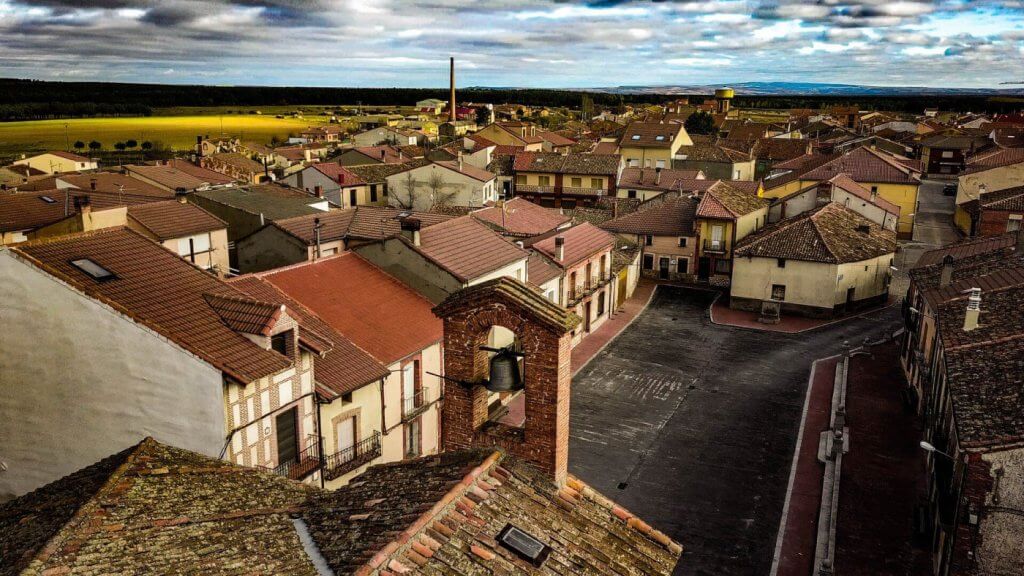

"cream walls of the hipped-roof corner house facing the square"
[730,254,893,313]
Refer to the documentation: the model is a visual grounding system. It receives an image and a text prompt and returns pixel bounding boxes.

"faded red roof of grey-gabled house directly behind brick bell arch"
[413,216,528,282]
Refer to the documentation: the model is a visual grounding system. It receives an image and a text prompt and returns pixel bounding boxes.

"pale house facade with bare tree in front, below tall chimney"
[387,164,498,212]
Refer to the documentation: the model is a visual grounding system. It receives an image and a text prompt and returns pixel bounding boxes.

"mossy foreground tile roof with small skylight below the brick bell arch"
[304,450,682,576]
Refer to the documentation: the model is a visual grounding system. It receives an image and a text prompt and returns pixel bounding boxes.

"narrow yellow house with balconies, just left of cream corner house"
[696,181,771,285]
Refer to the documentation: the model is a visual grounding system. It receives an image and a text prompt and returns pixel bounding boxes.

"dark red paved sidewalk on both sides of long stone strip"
[776,342,930,576]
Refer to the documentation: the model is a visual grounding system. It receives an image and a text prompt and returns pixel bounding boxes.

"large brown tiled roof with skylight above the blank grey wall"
[13,228,293,383]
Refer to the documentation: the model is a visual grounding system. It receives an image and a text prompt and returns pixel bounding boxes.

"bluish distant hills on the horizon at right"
[592,82,1024,96]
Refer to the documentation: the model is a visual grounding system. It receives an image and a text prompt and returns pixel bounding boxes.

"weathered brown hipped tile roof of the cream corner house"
[733,202,896,263]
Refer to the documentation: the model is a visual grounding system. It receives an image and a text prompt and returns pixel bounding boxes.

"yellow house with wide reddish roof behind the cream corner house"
[763,147,921,238]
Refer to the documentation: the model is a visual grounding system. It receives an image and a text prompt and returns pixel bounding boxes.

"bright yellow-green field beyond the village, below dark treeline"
[0,115,325,154]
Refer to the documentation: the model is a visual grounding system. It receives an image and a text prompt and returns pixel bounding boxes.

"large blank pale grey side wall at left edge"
[0,250,225,499]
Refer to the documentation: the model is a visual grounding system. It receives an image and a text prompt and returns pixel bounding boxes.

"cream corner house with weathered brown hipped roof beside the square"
[729,202,896,317]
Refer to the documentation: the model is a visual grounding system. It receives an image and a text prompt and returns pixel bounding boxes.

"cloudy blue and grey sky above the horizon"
[0,0,1024,87]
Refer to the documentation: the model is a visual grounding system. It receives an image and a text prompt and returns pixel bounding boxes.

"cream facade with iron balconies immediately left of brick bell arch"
[321,342,443,489]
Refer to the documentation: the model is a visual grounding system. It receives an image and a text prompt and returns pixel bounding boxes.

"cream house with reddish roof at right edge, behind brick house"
[953,148,1024,234]
